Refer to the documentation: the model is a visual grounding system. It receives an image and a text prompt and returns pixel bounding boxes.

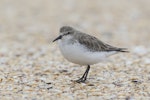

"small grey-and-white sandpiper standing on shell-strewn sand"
[53,26,128,83]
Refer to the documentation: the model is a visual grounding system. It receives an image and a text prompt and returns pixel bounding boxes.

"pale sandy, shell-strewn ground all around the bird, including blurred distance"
[0,0,150,100]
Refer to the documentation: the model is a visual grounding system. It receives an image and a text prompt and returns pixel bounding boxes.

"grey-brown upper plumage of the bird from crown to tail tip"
[60,26,128,52]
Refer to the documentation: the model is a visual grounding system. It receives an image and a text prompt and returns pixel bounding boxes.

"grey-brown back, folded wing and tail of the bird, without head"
[74,31,127,52]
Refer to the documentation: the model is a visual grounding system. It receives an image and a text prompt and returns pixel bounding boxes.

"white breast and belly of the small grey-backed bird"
[58,34,116,65]
